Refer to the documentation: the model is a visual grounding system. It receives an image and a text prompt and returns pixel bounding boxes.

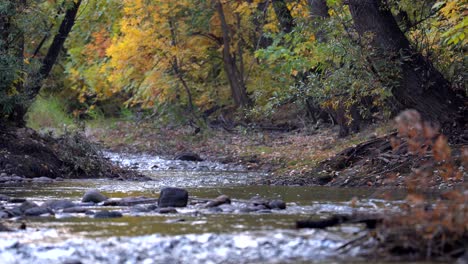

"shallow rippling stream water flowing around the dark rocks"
[0,153,401,264]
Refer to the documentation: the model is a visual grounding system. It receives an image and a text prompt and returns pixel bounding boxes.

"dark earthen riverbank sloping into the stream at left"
[0,127,145,183]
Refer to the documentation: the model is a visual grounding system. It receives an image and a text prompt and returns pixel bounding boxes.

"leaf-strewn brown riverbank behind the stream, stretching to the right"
[85,120,466,189]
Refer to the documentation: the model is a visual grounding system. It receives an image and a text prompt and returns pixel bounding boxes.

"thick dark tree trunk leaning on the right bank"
[348,0,463,124]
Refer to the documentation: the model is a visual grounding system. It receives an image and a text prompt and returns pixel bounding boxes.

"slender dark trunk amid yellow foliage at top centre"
[215,1,250,107]
